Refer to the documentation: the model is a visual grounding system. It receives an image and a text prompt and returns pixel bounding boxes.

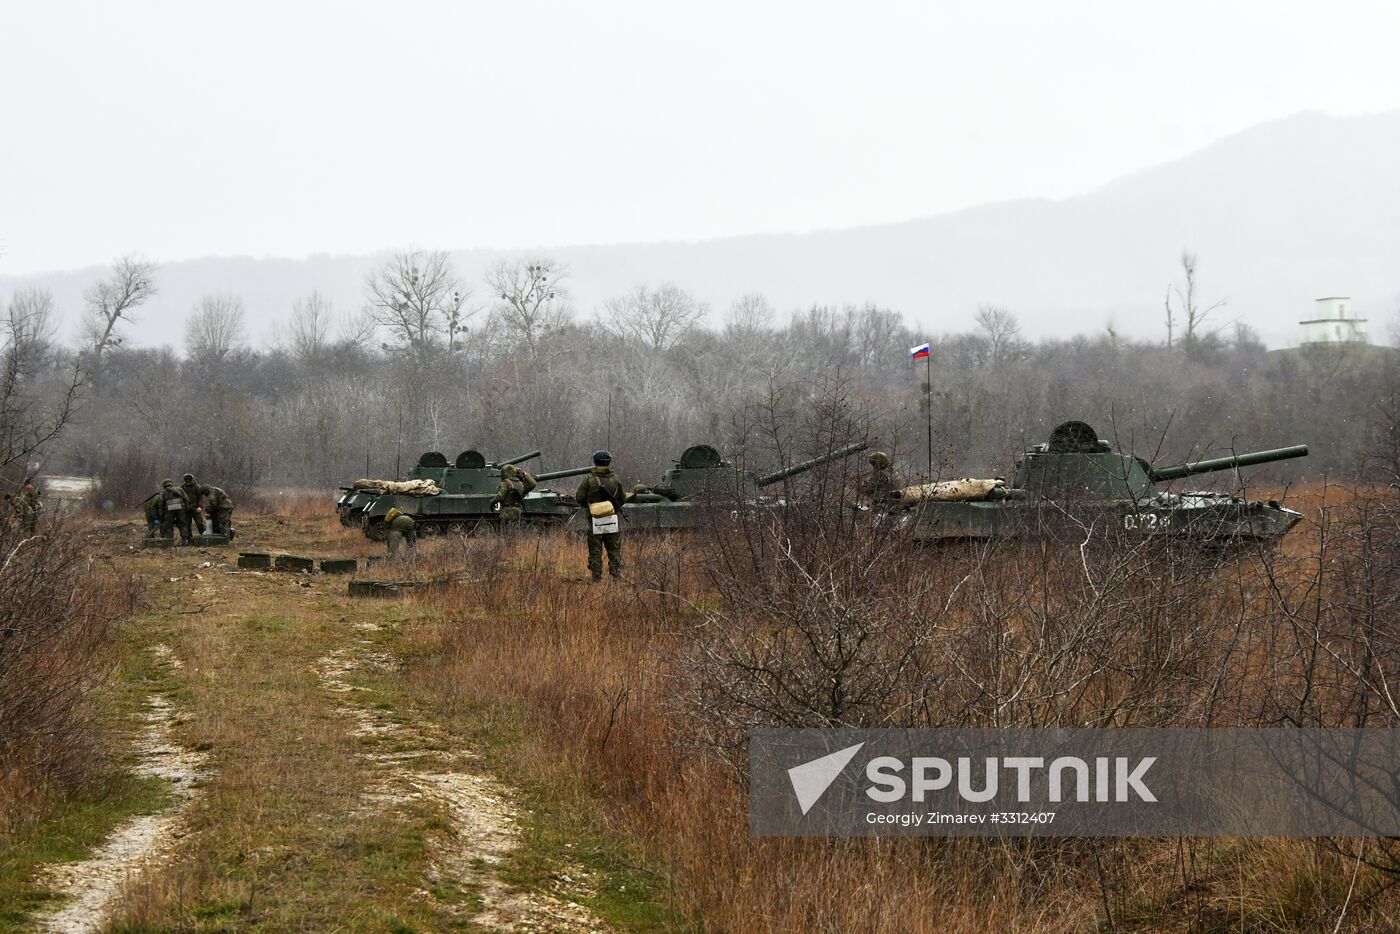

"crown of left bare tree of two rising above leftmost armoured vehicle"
[364,251,473,361]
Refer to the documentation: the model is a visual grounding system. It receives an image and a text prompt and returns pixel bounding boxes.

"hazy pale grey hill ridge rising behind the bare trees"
[0,112,1400,347]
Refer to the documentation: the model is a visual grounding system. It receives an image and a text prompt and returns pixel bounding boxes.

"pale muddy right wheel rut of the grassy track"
[316,622,608,933]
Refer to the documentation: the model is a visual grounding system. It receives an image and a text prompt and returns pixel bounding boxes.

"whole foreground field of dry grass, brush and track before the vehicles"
[8,487,1400,931]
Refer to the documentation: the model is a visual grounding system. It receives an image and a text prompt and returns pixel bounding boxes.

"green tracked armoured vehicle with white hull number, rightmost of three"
[902,421,1308,546]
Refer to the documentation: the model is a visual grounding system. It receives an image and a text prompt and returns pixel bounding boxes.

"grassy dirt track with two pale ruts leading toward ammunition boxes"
[17,520,605,933]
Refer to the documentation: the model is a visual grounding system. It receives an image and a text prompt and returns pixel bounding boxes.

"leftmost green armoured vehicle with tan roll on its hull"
[360,451,592,541]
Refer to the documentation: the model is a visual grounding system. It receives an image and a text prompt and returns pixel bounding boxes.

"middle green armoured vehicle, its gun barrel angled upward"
[568,441,869,532]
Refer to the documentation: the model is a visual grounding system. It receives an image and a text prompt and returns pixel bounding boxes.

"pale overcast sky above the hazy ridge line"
[0,0,1400,274]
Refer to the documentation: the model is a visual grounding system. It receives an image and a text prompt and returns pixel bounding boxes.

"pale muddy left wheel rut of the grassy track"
[34,644,206,934]
